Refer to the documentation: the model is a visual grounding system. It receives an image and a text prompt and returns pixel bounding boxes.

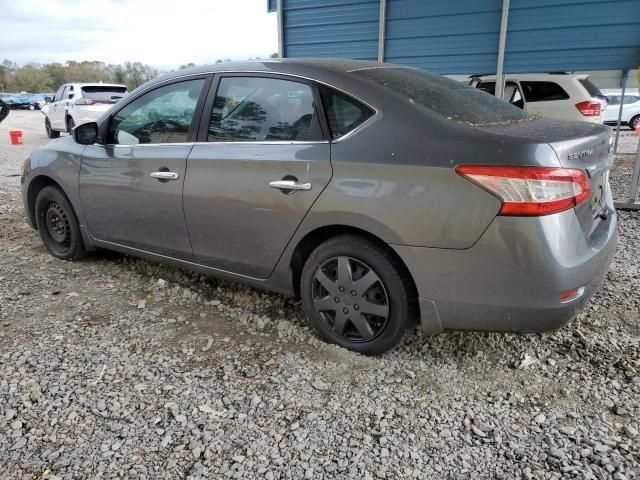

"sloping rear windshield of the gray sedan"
[353,68,528,125]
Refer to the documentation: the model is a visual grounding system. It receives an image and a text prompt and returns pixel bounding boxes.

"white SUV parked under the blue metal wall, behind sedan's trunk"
[469,73,607,123]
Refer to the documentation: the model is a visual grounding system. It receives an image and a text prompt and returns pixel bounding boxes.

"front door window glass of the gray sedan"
[107,79,204,145]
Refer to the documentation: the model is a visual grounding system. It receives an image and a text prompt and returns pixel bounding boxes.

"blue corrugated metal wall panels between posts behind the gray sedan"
[268,0,640,74]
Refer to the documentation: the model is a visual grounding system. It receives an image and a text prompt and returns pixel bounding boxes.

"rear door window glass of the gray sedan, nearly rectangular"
[208,77,319,142]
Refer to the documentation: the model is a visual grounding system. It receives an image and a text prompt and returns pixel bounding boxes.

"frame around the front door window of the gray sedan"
[97,73,213,148]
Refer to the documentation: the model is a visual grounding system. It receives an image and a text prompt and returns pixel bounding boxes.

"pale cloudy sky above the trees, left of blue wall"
[0,0,278,69]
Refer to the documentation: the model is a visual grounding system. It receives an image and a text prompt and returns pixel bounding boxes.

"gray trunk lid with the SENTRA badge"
[476,118,613,227]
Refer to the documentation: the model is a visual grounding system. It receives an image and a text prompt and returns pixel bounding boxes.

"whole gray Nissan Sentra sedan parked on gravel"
[22,60,616,354]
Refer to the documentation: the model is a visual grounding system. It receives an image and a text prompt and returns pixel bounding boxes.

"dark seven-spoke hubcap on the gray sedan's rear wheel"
[311,256,389,342]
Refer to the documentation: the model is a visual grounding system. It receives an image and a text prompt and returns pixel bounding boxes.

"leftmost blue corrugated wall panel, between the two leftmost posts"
[283,0,380,60]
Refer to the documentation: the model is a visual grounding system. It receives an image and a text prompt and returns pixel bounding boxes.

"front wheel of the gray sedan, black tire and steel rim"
[35,186,87,260]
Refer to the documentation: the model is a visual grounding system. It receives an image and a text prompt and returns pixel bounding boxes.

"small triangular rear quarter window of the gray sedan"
[320,86,374,139]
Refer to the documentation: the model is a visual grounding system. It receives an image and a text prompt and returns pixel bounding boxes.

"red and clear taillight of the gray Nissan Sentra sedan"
[456,165,589,216]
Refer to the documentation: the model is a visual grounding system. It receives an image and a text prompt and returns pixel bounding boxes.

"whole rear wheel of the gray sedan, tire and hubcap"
[300,235,417,355]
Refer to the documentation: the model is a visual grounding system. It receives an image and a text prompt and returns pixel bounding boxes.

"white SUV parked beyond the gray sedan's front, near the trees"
[41,83,129,138]
